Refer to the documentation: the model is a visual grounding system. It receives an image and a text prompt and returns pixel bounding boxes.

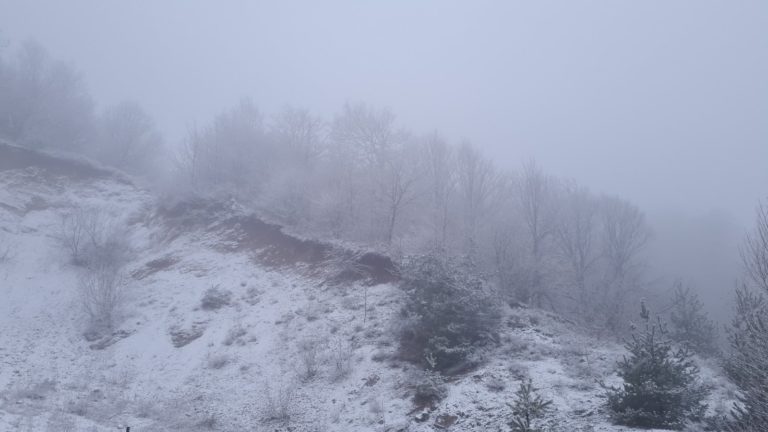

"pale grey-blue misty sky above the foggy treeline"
[0,0,768,230]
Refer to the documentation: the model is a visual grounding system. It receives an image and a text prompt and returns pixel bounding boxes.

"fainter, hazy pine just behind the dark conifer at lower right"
[669,281,719,356]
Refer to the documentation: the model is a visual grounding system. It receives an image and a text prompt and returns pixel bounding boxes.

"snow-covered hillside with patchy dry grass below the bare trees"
[0,146,732,432]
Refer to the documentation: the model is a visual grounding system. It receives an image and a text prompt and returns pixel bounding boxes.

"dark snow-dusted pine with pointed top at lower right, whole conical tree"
[608,303,708,429]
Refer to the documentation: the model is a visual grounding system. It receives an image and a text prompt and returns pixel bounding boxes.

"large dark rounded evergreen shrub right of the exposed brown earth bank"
[400,255,499,373]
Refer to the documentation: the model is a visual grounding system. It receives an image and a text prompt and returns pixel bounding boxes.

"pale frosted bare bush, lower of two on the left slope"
[79,266,126,335]
